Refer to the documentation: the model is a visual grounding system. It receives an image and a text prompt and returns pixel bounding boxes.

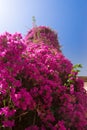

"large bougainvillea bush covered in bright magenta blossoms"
[0,26,87,130]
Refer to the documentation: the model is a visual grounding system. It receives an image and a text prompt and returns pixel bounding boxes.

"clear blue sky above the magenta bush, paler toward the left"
[0,0,87,75]
